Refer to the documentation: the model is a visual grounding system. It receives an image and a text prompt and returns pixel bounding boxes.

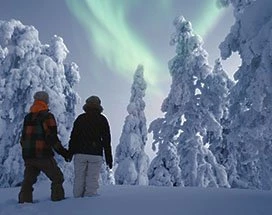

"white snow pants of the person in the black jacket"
[73,154,102,198]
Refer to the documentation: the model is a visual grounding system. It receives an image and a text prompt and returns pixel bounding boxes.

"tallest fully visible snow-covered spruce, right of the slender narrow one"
[149,17,229,187]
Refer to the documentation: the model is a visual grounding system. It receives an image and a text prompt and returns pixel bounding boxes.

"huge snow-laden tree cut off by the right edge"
[219,0,272,189]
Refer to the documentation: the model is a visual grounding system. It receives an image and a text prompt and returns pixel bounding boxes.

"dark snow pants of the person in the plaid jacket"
[19,157,64,203]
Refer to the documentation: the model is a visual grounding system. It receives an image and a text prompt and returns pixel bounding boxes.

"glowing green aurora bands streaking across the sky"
[66,0,222,91]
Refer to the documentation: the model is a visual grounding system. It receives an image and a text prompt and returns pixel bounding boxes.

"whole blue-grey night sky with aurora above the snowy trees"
[0,0,239,155]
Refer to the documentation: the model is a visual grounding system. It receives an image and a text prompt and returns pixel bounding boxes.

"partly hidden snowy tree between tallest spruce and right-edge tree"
[202,59,234,165]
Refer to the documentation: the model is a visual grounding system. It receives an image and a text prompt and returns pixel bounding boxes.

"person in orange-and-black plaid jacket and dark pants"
[19,91,69,203]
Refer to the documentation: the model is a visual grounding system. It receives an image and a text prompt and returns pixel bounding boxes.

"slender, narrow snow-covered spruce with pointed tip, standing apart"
[114,65,149,185]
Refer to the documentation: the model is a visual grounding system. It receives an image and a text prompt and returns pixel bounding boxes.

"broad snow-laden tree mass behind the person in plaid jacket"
[0,20,79,187]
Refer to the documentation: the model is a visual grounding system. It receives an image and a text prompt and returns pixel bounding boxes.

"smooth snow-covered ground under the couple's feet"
[0,182,272,215]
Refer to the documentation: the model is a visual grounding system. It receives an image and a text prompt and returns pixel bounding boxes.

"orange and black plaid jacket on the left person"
[20,110,65,159]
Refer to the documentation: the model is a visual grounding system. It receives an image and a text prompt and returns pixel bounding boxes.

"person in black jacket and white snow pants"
[69,96,112,198]
